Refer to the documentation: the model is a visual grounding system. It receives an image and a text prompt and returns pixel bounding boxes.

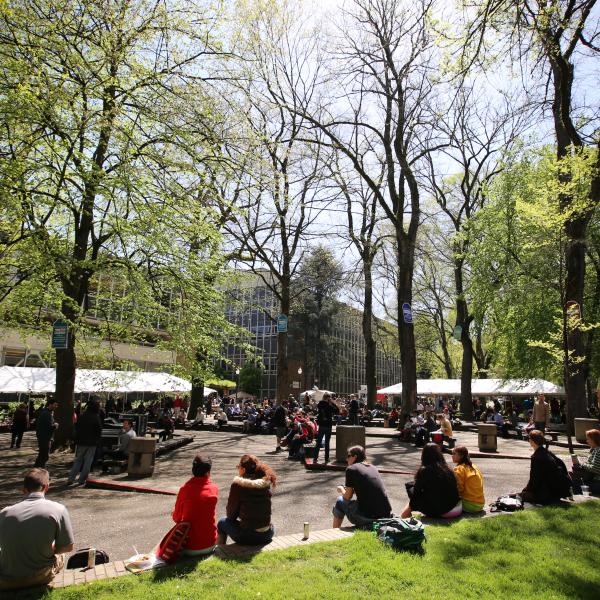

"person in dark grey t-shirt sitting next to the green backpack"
[332,446,392,528]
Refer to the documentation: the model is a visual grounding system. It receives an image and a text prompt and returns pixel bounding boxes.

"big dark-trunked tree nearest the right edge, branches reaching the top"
[463,0,600,416]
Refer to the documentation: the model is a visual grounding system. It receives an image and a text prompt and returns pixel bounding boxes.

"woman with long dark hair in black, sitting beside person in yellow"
[401,444,462,519]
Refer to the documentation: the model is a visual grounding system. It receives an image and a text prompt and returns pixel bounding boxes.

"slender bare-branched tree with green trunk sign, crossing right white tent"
[427,84,531,419]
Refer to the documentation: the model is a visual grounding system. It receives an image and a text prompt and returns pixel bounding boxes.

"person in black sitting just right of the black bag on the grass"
[521,429,572,504]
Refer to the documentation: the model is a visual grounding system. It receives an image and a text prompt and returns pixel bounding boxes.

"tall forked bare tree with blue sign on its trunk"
[288,0,443,414]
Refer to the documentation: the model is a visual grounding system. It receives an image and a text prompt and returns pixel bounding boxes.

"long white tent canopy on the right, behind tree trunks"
[377,379,565,396]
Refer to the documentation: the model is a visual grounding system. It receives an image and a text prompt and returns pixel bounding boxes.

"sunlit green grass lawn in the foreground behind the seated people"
[20,501,600,600]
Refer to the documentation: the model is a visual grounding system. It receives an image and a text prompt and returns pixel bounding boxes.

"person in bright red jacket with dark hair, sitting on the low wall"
[173,454,219,556]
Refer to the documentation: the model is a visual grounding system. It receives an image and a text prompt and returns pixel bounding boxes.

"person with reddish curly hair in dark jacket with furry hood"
[217,454,277,546]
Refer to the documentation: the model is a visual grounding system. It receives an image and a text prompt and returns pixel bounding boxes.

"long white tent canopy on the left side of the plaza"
[0,367,202,396]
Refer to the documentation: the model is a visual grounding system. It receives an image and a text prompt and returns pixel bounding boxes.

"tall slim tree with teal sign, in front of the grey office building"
[222,2,327,399]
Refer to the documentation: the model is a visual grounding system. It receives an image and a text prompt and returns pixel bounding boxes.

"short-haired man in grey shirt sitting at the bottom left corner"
[0,468,73,590]
